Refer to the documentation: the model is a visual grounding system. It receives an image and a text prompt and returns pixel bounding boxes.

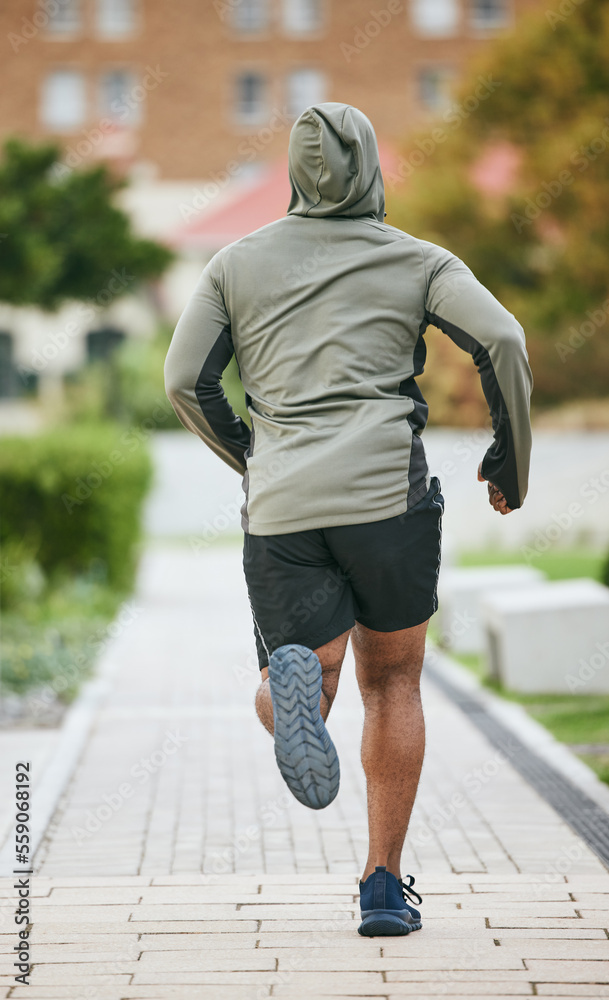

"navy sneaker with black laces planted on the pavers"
[357,867,423,937]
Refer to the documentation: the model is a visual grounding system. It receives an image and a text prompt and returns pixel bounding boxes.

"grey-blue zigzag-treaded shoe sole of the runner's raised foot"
[269,645,340,809]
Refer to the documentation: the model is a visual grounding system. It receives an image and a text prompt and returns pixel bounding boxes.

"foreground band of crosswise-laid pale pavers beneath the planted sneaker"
[0,872,609,1000]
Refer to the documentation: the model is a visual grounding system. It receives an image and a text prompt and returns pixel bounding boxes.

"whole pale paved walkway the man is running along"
[0,545,609,1000]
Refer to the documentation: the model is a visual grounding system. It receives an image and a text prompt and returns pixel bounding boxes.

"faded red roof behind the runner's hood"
[171,144,396,251]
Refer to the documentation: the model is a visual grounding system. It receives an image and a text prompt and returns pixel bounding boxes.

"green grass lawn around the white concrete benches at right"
[444,549,609,784]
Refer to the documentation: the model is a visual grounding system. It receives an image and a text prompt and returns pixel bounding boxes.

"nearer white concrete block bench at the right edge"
[480,579,609,694]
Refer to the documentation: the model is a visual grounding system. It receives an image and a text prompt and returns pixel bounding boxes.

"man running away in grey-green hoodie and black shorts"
[165,104,532,936]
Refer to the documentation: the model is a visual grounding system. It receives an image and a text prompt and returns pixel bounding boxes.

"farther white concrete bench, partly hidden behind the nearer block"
[437,565,545,653]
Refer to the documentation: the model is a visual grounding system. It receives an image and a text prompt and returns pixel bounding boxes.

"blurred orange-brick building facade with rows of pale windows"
[0,0,540,180]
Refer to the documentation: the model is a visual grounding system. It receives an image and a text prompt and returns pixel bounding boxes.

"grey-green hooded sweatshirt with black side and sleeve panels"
[165,104,532,535]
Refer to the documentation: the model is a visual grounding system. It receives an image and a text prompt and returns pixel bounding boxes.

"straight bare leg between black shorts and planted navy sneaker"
[351,622,427,880]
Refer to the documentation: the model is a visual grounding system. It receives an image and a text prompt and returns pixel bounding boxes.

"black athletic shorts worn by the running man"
[243,477,444,669]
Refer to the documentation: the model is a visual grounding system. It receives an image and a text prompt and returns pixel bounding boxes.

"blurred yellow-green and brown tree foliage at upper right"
[388,0,609,407]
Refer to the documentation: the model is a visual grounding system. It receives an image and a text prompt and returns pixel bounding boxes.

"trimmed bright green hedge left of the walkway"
[0,425,152,592]
